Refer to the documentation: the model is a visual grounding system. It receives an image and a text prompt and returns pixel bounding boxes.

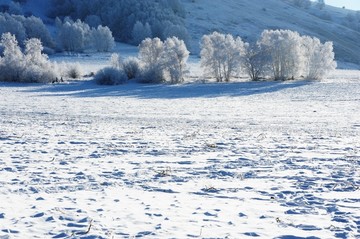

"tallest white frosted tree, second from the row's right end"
[258,30,304,80]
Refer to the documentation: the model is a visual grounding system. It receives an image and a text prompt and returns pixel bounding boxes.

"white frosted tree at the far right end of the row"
[302,36,336,80]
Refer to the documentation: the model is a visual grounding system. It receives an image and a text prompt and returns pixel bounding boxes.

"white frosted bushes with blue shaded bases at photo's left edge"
[0,33,57,83]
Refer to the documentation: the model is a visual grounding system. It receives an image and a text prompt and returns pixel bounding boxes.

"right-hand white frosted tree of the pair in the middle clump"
[161,37,189,84]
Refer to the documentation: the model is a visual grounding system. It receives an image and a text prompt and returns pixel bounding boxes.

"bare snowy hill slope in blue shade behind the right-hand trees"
[182,0,360,64]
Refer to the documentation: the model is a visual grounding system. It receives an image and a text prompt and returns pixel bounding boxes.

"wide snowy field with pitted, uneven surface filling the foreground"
[0,71,360,239]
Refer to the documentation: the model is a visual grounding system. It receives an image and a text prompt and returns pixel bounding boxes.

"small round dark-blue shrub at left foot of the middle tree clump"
[94,67,128,85]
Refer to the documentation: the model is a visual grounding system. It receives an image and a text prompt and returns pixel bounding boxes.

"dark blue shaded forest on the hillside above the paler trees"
[49,0,189,45]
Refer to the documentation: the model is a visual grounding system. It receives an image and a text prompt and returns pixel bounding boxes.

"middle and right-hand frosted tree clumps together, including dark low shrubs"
[95,30,336,84]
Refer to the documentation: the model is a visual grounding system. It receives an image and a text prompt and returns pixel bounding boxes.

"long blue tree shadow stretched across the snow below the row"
[21,80,312,99]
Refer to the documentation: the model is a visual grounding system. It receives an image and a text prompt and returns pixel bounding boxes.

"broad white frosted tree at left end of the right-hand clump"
[200,32,245,82]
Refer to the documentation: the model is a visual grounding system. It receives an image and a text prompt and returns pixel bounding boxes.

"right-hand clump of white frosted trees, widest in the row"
[200,30,336,81]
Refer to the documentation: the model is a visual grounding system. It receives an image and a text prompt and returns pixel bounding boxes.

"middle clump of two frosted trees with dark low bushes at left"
[95,37,189,85]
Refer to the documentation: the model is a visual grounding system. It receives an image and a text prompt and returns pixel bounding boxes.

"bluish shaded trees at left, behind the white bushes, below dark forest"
[0,13,115,52]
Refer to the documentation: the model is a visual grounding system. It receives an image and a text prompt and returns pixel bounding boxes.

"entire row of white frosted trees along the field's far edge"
[0,29,336,84]
